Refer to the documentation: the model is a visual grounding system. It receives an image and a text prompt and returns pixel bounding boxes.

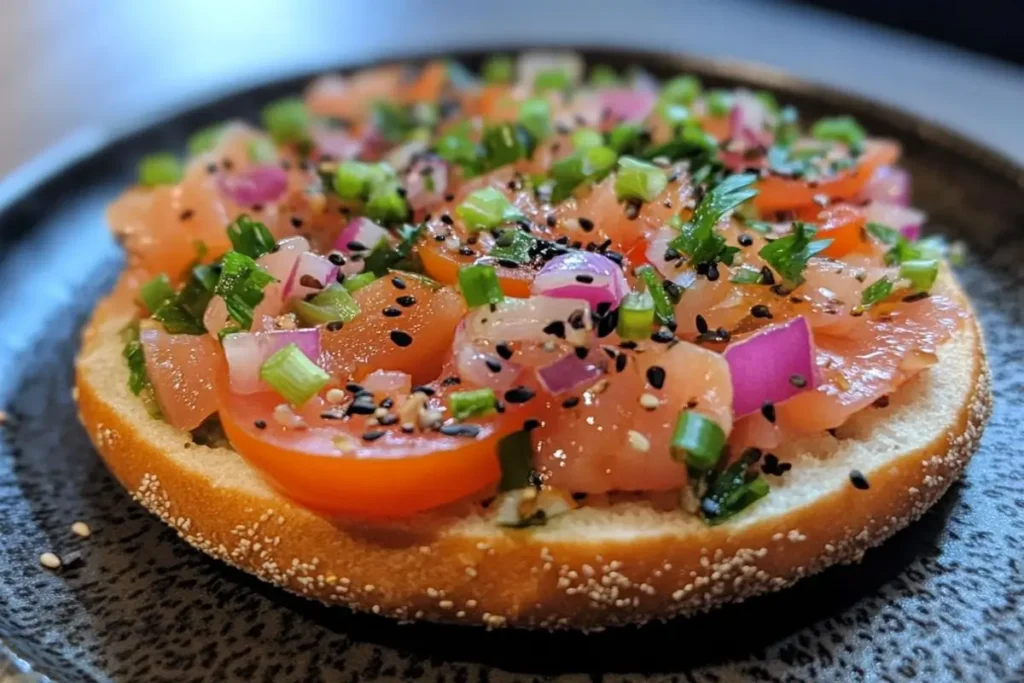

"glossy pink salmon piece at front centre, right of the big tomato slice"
[532,342,732,493]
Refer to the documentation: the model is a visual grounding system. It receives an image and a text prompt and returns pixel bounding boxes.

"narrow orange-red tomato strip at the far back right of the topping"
[754,140,899,213]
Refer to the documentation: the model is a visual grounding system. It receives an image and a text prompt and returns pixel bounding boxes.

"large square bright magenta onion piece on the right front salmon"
[724,315,817,418]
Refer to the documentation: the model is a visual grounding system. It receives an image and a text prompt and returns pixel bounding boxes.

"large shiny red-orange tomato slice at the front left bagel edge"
[216,369,521,517]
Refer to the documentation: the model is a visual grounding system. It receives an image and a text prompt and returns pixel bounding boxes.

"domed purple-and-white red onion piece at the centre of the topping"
[532,251,629,308]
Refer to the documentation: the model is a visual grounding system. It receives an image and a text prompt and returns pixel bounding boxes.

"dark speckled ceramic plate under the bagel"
[0,50,1024,681]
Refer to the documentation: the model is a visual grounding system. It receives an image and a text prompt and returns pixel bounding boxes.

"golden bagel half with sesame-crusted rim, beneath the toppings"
[77,275,991,629]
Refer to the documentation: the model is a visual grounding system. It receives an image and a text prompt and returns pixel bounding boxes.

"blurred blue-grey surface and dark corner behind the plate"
[0,0,1024,177]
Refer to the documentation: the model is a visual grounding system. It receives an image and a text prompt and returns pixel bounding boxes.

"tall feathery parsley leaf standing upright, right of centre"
[669,173,758,264]
